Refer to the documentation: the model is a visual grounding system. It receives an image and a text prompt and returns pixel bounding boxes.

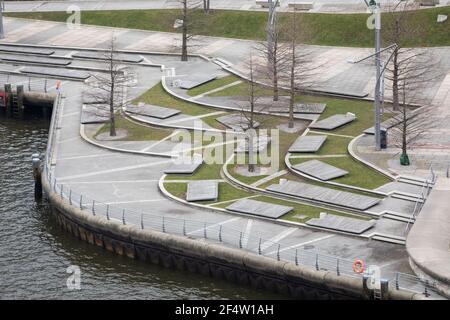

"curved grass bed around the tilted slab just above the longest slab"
[291,156,391,189]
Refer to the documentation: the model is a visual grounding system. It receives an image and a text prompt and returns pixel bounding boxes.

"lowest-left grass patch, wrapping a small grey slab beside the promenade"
[164,182,253,204]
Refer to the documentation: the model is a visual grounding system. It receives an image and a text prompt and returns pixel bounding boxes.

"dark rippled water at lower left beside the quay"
[0,116,283,299]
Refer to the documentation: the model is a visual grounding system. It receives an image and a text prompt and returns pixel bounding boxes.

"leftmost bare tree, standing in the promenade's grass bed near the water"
[87,36,130,136]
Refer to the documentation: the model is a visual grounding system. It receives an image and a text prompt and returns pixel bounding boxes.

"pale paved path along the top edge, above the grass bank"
[5,0,448,13]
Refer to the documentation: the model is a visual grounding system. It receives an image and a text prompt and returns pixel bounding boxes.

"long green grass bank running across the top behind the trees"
[5,7,450,47]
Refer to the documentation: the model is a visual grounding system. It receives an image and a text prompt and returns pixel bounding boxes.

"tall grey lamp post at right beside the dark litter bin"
[374,3,381,151]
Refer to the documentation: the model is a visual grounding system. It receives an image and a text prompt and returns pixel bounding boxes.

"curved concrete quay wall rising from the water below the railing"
[42,168,424,299]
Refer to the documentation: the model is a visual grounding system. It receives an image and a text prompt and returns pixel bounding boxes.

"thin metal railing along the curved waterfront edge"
[43,93,438,293]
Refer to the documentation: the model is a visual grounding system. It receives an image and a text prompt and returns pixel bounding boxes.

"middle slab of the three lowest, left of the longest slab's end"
[226,199,294,219]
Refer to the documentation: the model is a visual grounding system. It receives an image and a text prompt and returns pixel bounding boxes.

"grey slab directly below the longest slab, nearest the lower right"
[306,214,376,234]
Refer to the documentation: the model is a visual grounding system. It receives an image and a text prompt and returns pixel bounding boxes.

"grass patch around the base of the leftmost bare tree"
[94,115,171,141]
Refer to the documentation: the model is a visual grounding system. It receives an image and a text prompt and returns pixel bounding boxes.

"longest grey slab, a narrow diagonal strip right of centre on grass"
[266,181,381,211]
